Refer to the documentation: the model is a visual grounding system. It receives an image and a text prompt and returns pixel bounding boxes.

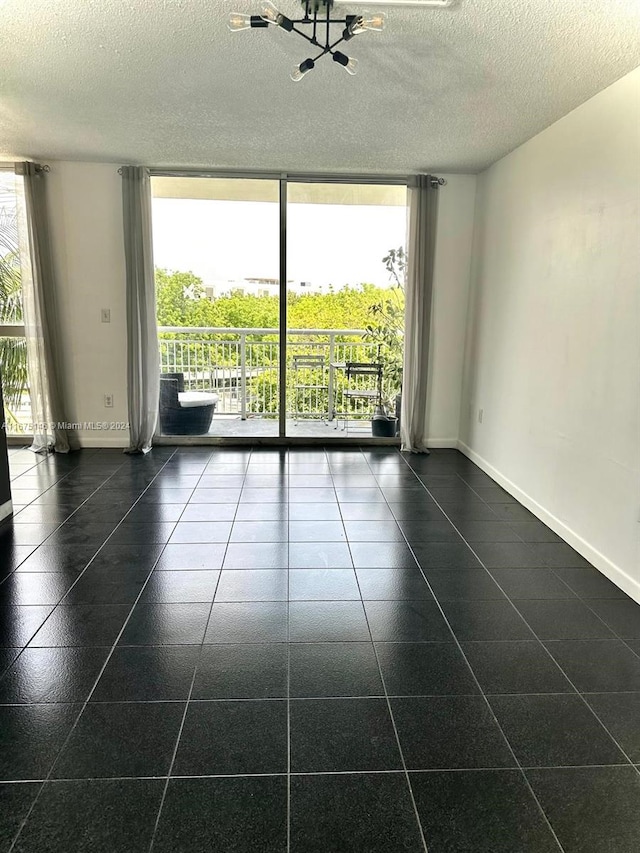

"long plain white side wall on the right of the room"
[460,69,640,600]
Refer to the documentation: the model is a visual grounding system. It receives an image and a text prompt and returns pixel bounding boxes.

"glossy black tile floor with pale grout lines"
[0,447,640,853]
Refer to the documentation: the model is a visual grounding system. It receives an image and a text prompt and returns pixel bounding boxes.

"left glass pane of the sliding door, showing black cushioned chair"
[152,178,280,437]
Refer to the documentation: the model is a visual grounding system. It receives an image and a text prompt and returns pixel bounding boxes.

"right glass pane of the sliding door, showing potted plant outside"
[287,183,407,439]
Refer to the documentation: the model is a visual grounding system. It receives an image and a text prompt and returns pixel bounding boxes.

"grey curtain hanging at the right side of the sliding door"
[400,175,439,453]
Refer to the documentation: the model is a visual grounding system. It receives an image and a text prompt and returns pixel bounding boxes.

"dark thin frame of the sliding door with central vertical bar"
[149,169,412,447]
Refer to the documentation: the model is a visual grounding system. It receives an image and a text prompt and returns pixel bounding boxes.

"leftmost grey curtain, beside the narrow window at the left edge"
[16,162,78,453]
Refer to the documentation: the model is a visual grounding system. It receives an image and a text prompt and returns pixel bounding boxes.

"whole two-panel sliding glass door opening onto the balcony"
[152,175,406,441]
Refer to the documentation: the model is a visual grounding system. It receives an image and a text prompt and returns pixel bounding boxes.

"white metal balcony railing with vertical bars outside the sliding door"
[158,326,395,419]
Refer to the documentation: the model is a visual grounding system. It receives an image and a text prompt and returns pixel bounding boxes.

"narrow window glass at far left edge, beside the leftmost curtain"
[0,170,32,435]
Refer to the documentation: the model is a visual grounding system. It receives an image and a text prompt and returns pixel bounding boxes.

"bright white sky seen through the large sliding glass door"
[153,198,406,289]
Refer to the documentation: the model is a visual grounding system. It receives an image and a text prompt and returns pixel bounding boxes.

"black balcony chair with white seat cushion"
[160,373,218,435]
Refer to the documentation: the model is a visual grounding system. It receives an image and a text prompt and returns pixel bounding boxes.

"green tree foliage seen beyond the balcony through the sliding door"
[156,253,406,417]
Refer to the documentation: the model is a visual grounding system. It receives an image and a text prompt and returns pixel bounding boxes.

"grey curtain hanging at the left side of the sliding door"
[121,166,160,453]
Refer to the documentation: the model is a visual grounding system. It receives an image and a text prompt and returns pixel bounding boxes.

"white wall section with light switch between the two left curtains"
[47,162,129,447]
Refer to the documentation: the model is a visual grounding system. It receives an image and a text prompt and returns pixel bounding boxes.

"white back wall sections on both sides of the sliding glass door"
[43,162,476,447]
